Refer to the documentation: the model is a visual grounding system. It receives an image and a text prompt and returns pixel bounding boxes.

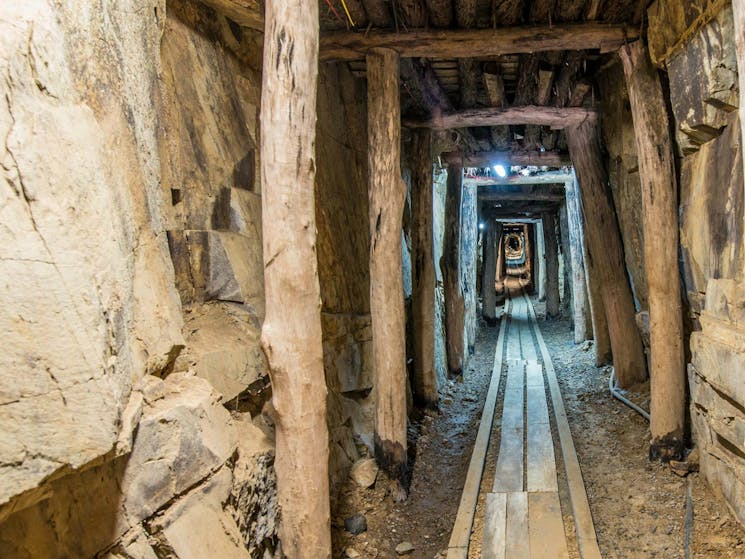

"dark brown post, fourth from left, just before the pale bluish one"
[440,164,466,377]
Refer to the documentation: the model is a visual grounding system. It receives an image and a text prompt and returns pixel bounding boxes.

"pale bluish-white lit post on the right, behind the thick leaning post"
[564,177,592,344]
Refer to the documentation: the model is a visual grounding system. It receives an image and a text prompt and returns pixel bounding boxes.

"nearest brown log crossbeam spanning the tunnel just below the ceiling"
[321,23,639,62]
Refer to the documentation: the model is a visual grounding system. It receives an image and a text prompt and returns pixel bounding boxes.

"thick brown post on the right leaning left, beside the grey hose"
[567,121,647,388]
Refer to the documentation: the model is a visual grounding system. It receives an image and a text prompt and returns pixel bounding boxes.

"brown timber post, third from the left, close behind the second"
[411,130,439,408]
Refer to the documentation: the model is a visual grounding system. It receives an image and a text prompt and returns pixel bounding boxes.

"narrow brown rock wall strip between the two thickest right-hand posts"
[598,64,649,311]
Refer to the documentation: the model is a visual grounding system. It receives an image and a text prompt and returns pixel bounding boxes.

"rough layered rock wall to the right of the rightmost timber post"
[650,0,745,523]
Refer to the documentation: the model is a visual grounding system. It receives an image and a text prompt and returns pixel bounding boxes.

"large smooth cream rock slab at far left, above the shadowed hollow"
[0,0,184,524]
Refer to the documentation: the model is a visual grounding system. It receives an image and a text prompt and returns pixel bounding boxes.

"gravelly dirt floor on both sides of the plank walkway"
[332,303,745,559]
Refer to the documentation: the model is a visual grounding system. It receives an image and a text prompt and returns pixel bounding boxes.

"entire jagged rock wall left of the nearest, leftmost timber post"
[0,0,277,559]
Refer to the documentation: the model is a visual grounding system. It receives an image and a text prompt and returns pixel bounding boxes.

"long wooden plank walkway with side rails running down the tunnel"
[448,294,601,559]
